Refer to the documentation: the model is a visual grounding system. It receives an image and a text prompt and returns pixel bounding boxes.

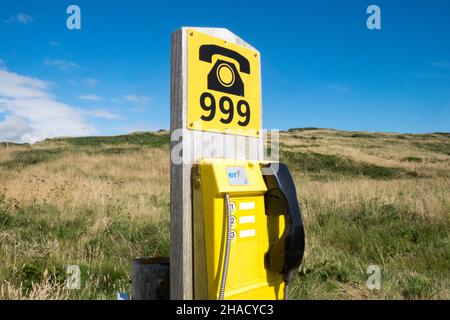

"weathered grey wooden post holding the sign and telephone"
[170,27,264,299]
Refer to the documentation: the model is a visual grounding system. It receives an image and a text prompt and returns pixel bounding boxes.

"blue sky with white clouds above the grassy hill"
[0,0,450,141]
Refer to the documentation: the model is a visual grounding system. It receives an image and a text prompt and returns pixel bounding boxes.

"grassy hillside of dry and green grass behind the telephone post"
[0,128,450,299]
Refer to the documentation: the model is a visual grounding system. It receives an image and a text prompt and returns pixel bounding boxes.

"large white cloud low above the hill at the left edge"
[0,69,96,143]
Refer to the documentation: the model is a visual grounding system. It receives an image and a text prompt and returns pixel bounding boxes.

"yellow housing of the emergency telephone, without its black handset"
[193,159,285,300]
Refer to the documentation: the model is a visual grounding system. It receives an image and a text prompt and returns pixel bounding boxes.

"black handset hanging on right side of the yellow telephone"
[262,163,305,282]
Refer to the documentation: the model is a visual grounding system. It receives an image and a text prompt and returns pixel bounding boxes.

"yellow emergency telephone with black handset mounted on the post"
[192,159,305,300]
